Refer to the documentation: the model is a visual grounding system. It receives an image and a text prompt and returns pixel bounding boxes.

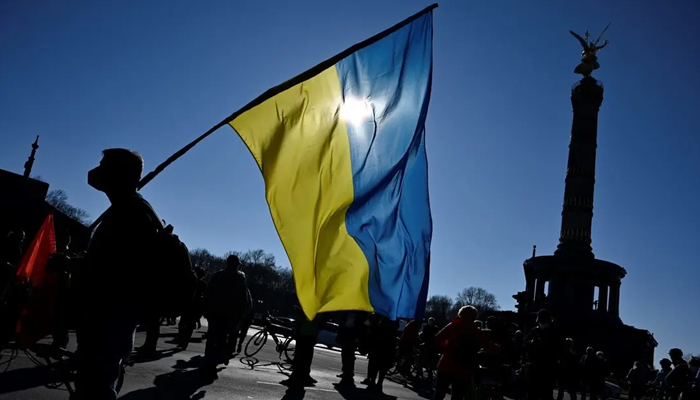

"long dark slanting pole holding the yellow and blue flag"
[138,3,438,190]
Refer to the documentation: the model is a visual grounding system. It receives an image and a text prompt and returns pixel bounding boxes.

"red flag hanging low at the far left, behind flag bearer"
[16,214,57,348]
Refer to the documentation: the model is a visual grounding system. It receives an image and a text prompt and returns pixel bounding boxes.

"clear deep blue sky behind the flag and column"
[0,0,700,360]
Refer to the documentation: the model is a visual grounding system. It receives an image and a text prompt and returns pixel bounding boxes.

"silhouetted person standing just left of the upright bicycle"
[203,255,248,374]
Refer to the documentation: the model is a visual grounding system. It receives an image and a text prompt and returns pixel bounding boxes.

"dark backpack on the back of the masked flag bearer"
[136,198,197,318]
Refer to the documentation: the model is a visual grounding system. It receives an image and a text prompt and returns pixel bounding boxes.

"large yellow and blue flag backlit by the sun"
[228,5,437,319]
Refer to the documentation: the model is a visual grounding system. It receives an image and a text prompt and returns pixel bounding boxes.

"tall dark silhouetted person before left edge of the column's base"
[525,310,564,400]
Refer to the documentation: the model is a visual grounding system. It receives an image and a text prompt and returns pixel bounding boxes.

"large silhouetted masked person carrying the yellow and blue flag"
[76,149,160,400]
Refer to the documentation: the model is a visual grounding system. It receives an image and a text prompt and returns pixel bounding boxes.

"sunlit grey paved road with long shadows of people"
[0,327,429,400]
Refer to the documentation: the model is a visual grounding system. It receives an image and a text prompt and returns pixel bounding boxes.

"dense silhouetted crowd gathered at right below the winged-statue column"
[338,306,700,400]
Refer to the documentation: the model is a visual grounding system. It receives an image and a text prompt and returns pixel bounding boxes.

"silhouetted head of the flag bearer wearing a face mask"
[88,149,143,196]
